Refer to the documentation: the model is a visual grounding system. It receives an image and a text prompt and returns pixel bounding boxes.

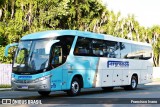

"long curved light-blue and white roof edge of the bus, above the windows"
[21,30,151,47]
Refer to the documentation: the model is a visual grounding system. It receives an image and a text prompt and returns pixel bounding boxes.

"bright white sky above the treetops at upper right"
[102,0,160,27]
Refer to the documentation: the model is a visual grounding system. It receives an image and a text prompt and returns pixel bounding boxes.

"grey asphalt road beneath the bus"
[0,81,160,107]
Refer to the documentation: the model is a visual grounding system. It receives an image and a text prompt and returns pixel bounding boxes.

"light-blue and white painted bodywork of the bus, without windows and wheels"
[9,30,152,91]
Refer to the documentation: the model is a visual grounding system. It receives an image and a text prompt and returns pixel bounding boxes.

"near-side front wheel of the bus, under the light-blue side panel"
[67,78,81,96]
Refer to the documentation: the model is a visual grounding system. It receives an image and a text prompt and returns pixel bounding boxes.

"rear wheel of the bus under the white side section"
[124,76,138,90]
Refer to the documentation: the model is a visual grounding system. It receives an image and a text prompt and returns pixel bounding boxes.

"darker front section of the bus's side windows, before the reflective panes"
[74,37,120,58]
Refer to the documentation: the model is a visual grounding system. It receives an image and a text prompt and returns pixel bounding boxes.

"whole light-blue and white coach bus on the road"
[5,30,152,96]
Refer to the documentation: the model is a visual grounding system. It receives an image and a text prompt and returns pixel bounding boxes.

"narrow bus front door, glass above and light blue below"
[50,42,64,91]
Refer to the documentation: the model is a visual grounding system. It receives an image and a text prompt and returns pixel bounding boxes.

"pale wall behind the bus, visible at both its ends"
[0,64,160,85]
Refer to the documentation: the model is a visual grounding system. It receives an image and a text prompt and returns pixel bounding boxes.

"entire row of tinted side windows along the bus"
[74,37,152,59]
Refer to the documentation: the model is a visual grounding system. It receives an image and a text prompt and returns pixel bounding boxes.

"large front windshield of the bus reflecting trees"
[13,39,56,73]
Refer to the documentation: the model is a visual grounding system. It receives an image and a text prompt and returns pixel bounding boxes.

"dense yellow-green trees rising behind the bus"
[0,0,160,66]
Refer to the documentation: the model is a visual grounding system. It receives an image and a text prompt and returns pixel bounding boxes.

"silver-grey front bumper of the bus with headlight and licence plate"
[11,76,51,91]
